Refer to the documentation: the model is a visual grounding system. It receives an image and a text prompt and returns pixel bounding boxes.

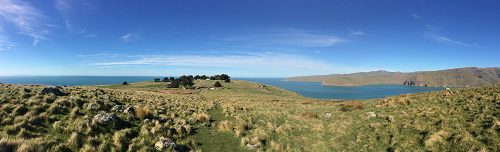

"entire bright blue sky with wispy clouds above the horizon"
[0,0,500,77]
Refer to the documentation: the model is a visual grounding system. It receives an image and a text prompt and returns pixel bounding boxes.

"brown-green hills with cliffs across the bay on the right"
[286,67,500,87]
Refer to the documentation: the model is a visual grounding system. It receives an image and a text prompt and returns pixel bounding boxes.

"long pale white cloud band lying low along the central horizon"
[81,52,370,76]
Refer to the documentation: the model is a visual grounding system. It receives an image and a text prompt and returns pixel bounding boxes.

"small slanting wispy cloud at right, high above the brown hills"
[422,25,478,47]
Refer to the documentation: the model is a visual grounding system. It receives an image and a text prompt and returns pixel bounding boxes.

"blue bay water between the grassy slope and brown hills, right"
[242,78,443,99]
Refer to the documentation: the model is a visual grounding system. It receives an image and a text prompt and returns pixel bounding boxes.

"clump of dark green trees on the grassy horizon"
[154,74,231,89]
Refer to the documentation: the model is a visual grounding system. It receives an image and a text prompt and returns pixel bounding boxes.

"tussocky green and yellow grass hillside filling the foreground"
[0,80,500,151]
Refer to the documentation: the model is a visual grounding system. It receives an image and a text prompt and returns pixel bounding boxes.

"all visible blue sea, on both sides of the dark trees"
[0,76,443,99]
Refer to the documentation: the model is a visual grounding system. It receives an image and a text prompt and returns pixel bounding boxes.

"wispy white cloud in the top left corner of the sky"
[0,0,49,46]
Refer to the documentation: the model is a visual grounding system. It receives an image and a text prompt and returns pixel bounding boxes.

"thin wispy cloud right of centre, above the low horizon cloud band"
[222,28,346,47]
